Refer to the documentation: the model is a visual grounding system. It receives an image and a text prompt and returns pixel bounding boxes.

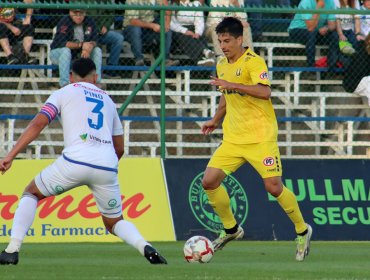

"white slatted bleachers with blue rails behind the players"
[0,5,370,158]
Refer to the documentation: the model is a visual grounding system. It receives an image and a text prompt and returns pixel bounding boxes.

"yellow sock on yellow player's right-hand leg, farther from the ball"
[276,187,307,234]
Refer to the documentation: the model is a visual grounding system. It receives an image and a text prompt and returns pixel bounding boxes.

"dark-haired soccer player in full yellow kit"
[201,17,312,261]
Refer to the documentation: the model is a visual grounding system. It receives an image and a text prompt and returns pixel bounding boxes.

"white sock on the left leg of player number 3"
[5,193,38,253]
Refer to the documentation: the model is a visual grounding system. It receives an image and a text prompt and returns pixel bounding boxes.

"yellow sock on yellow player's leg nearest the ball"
[205,186,237,229]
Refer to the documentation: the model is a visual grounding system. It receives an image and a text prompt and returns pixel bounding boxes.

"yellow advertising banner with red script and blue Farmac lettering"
[0,158,175,243]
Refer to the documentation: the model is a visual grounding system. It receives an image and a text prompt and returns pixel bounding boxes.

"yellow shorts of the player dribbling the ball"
[208,141,283,178]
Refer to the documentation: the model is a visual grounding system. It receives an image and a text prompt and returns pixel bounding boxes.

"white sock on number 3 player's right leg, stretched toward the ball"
[113,220,150,256]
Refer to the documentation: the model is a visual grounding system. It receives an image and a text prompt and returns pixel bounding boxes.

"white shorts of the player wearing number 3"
[35,156,122,218]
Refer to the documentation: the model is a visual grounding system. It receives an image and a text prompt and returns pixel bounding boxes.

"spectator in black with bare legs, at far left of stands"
[0,0,34,64]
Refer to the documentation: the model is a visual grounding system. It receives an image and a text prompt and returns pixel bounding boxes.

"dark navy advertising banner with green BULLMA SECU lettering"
[165,159,370,240]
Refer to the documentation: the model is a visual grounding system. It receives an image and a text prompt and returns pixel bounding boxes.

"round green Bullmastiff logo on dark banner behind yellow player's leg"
[188,172,249,232]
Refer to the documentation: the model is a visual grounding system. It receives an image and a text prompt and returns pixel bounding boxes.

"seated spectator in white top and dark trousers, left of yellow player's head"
[170,0,215,66]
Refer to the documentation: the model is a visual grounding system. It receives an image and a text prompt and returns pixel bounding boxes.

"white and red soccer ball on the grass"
[184,235,215,263]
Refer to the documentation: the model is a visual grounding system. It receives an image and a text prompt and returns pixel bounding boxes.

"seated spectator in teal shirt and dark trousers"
[288,0,339,70]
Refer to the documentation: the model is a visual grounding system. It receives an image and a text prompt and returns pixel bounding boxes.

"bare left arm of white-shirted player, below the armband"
[0,114,49,174]
